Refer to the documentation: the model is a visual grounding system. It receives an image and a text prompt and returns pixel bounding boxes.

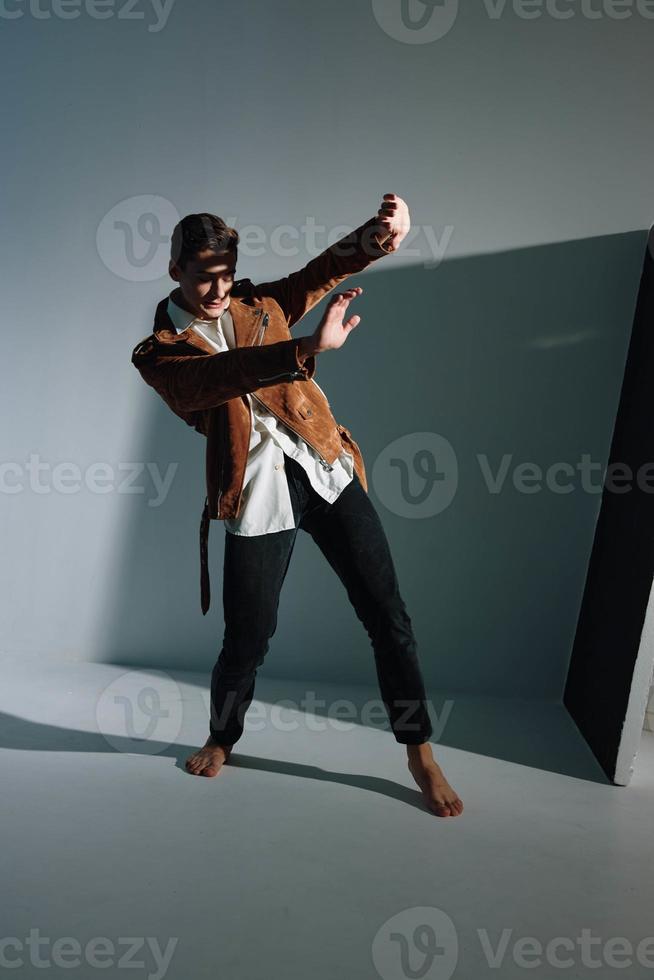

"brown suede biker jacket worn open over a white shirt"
[132,218,392,613]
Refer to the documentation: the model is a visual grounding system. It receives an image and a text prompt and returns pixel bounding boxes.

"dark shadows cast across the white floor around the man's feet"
[0,665,612,788]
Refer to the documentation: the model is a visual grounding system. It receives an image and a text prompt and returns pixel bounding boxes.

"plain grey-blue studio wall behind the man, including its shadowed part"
[0,0,654,698]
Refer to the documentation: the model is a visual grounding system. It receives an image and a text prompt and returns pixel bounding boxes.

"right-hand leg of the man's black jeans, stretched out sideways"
[299,473,433,745]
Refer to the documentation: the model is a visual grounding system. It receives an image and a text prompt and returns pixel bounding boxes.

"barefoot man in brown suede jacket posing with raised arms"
[132,194,463,816]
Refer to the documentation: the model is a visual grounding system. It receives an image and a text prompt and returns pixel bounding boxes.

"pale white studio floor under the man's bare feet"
[0,657,654,980]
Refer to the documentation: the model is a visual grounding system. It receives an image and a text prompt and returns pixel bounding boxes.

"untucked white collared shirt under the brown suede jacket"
[168,297,354,537]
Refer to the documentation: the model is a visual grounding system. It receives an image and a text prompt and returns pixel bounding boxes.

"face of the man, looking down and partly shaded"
[169,249,236,320]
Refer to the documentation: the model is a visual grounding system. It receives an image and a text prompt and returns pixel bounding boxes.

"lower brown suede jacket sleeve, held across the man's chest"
[132,337,316,416]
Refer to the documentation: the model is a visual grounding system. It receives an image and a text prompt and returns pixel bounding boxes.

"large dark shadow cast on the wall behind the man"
[100,231,647,700]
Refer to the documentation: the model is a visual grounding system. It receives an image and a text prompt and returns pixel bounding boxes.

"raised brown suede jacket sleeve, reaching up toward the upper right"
[254,218,393,327]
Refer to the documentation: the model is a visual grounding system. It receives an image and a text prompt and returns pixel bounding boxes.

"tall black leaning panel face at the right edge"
[564,233,654,778]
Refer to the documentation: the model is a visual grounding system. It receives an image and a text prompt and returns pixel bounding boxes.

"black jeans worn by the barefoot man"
[210,454,432,745]
